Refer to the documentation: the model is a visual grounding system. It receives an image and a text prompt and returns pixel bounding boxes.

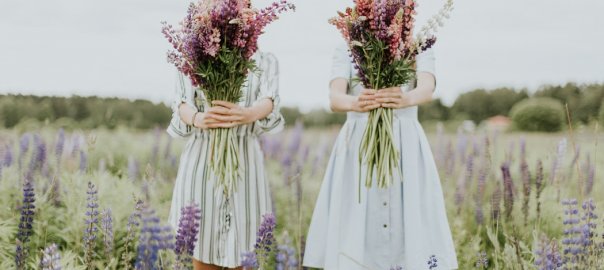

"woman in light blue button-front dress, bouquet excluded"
[304,45,457,270]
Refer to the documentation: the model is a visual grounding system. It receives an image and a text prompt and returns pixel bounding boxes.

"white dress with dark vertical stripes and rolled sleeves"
[167,53,284,268]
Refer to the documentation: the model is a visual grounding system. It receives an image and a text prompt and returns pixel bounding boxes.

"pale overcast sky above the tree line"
[0,0,604,109]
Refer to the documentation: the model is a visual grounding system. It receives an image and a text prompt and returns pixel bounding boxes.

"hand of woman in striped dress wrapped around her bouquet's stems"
[210,100,255,128]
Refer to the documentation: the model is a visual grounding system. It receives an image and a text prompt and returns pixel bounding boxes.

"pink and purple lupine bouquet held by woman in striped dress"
[162,0,295,194]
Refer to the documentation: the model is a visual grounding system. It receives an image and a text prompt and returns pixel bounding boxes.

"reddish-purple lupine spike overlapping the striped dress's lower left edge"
[174,204,201,266]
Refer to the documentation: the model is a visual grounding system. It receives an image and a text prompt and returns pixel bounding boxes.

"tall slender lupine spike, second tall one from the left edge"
[83,182,99,269]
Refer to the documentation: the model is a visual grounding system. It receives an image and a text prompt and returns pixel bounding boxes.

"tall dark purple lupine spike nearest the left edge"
[15,179,36,269]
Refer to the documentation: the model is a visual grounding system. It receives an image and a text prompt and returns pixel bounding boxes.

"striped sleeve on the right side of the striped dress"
[255,53,285,134]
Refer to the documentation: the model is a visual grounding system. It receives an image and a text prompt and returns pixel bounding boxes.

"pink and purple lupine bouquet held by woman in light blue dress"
[329,0,453,195]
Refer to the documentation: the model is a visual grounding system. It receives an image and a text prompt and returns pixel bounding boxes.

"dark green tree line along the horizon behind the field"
[0,83,604,129]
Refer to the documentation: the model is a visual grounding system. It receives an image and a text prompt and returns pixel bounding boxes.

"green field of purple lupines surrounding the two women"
[0,125,604,270]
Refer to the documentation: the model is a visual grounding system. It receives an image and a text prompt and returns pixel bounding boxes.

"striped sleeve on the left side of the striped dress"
[166,77,197,138]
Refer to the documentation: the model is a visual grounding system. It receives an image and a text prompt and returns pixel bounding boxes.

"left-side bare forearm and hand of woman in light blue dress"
[329,78,380,112]
